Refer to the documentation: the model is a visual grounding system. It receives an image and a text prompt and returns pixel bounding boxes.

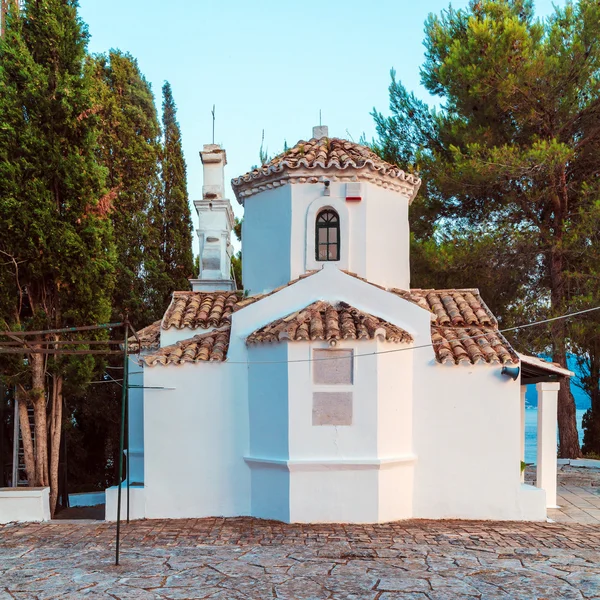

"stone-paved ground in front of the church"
[0,518,600,600]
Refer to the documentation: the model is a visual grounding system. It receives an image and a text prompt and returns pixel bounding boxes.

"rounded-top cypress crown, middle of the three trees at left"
[95,50,165,327]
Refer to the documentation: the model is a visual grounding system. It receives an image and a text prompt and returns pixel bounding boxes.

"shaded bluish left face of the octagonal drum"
[242,185,292,295]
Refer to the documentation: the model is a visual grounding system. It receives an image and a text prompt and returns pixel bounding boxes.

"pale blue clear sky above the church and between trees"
[80,0,564,232]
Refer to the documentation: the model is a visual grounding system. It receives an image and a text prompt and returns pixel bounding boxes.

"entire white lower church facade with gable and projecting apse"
[134,264,545,522]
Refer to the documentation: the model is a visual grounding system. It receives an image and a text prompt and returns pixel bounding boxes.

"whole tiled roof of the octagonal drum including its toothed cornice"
[231,137,421,204]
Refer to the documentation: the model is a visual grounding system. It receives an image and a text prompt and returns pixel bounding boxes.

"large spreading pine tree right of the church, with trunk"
[375,0,600,458]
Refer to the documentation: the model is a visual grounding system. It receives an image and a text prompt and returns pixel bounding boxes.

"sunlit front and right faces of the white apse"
[288,340,415,523]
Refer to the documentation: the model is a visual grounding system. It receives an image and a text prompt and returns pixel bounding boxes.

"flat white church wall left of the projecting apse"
[144,363,250,518]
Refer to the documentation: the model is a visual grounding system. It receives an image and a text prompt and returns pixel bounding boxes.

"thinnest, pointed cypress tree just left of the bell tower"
[159,81,194,300]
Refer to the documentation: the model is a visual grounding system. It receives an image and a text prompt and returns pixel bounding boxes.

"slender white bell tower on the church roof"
[190,144,235,292]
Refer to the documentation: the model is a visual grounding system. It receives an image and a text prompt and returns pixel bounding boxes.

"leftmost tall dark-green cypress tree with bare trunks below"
[0,0,115,513]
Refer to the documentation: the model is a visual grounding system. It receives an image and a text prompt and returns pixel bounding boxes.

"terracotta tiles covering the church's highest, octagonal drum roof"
[231,137,421,199]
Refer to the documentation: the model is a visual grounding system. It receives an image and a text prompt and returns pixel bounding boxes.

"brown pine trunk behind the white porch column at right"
[550,246,581,458]
